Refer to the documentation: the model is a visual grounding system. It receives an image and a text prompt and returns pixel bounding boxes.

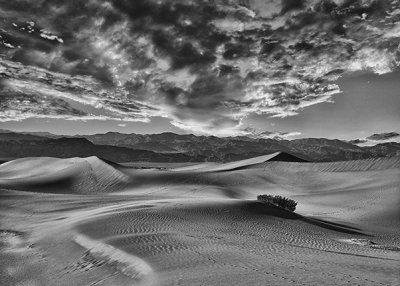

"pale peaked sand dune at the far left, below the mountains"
[0,156,128,194]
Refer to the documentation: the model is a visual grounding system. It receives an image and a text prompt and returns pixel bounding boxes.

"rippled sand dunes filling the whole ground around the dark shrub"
[0,157,400,285]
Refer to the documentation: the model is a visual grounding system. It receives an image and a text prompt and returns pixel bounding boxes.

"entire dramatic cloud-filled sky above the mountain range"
[0,0,400,140]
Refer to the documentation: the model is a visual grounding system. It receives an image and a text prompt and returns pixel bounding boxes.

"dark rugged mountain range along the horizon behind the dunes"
[0,130,400,162]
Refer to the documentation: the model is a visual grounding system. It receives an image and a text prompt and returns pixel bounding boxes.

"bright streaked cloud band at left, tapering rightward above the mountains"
[0,61,163,122]
